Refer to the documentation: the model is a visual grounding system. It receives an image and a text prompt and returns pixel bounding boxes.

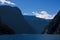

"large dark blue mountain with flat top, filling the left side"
[0,5,36,34]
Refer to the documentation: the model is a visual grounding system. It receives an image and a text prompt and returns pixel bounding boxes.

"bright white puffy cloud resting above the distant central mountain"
[32,11,55,19]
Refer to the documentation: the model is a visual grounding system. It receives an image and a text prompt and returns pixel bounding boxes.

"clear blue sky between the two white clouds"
[13,0,60,15]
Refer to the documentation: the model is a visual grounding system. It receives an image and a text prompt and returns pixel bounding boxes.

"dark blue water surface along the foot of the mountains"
[0,34,60,40]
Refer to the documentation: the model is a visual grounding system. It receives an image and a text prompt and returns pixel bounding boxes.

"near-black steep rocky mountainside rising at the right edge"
[43,11,60,34]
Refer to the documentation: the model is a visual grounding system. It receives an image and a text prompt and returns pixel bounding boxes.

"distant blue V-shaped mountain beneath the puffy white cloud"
[24,15,51,34]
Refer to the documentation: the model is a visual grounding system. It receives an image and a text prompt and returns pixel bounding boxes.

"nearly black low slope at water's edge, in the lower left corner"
[0,24,15,34]
